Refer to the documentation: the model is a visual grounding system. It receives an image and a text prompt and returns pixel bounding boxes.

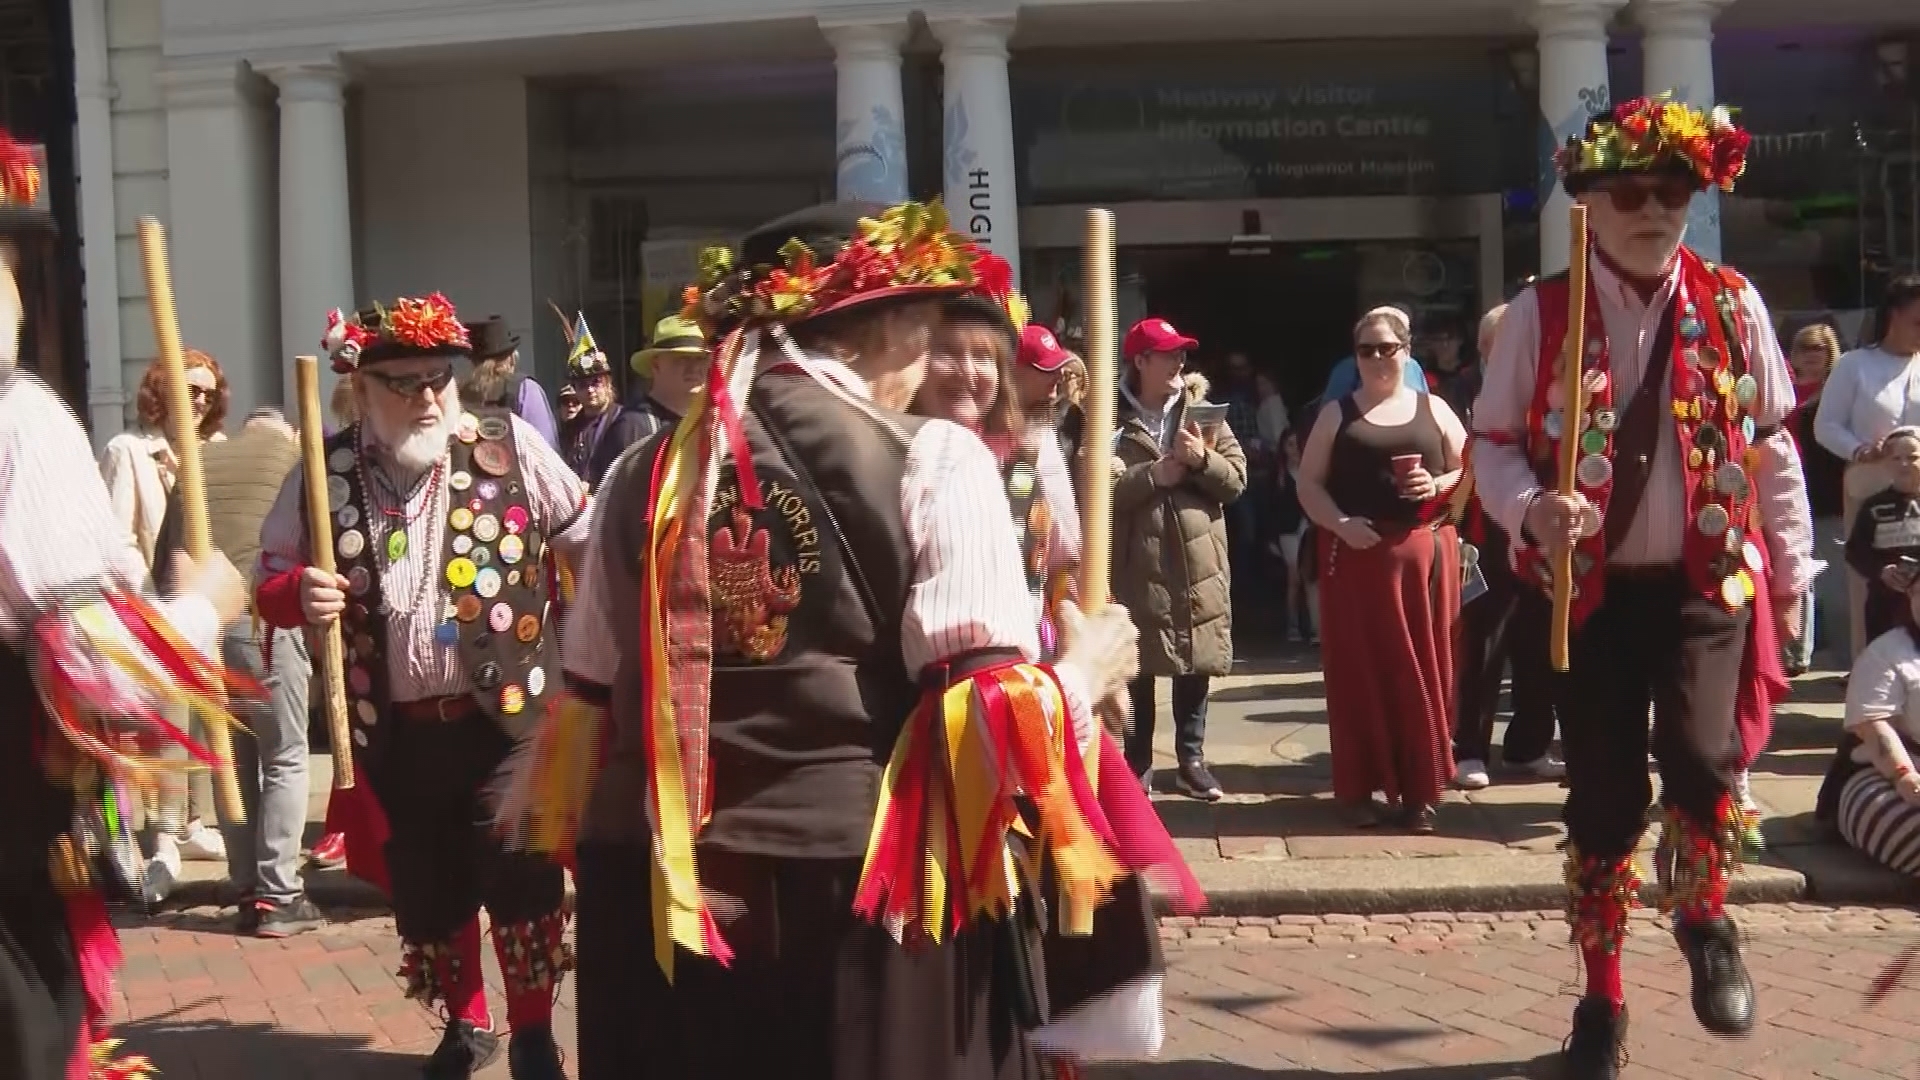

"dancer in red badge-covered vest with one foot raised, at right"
[1473,98,1812,1080]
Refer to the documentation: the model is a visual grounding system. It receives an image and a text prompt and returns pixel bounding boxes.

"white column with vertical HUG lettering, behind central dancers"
[929,17,1020,284]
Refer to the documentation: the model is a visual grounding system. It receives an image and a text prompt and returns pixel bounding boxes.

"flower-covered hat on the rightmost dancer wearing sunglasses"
[1553,94,1751,194]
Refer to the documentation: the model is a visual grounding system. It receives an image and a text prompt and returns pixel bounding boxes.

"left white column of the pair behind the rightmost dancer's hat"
[1530,0,1626,275]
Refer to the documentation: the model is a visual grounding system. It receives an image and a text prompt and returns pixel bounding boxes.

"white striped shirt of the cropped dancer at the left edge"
[0,373,219,655]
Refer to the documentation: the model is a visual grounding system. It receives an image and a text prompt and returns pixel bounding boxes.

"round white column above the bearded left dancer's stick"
[267,58,353,403]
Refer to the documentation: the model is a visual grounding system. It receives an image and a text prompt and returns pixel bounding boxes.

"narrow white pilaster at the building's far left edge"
[73,0,127,441]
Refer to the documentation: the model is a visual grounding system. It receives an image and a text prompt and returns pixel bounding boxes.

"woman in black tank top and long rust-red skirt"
[1300,309,1467,832]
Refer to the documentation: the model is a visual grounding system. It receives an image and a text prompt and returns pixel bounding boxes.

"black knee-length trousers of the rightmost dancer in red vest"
[1523,569,1751,859]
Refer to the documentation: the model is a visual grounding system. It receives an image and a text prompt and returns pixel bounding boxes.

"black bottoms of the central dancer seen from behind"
[574,842,1041,1080]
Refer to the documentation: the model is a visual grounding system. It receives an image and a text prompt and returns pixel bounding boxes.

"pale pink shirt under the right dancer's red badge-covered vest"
[1473,258,1824,596]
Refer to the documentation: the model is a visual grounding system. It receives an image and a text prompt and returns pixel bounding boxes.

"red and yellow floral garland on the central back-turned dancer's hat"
[682,200,1014,327]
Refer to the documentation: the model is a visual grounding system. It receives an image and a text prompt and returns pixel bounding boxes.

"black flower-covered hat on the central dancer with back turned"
[682,202,1012,331]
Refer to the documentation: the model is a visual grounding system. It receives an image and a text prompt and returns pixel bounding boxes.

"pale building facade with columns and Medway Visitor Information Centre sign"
[71,0,1920,428]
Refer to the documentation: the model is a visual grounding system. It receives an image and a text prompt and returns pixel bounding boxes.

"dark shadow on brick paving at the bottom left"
[115,1017,424,1080]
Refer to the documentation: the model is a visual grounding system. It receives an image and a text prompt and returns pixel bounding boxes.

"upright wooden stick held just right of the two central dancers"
[1079,209,1119,611]
